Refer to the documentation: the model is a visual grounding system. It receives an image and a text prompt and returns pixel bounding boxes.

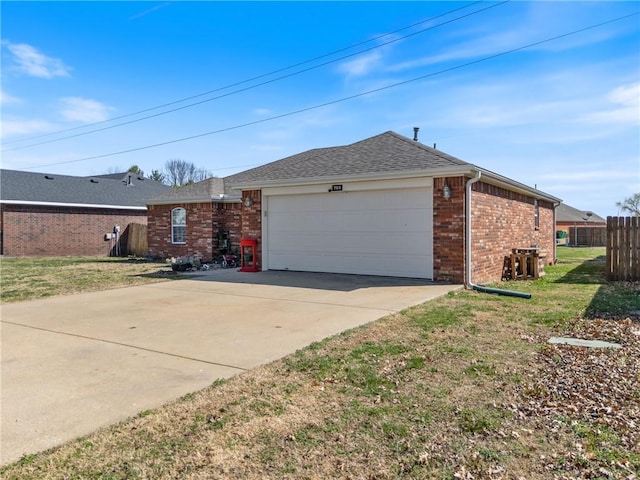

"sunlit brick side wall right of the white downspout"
[471,182,555,284]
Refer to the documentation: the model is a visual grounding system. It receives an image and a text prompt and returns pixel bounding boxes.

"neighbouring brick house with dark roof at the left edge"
[0,169,169,257]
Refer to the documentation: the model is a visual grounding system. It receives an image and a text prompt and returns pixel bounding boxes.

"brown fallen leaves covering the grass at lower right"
[508,318,640,480]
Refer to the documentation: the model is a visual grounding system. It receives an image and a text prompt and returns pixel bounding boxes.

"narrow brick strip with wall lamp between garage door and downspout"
[433,177,466,283]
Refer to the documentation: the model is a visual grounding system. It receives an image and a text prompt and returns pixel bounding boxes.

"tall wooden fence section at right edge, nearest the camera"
[606,217,640,281]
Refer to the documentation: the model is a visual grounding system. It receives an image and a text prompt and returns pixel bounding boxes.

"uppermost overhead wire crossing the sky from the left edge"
[3,0,484,147]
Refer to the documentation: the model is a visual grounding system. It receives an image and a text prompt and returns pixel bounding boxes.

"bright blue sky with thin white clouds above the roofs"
[0,1,640,216]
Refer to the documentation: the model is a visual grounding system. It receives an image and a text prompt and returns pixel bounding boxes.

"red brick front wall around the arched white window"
[147,202,241,262]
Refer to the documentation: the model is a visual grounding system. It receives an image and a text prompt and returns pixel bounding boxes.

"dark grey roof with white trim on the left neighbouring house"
[0,169,169,210]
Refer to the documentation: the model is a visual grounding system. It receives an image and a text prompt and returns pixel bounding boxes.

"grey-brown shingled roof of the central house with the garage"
[149,132,560,204]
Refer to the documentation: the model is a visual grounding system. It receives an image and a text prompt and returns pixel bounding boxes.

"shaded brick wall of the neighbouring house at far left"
[0,205,147,257]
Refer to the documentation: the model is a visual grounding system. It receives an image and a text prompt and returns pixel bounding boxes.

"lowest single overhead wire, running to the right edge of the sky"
[22,12,640,168]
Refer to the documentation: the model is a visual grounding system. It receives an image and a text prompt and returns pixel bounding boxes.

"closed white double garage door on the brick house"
[263,187,433,278]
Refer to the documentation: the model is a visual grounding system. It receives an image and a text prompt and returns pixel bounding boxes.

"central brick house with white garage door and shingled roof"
[148,132,560,285]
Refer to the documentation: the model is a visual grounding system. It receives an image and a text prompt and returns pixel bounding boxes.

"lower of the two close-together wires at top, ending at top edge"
[2,0,504,152]
